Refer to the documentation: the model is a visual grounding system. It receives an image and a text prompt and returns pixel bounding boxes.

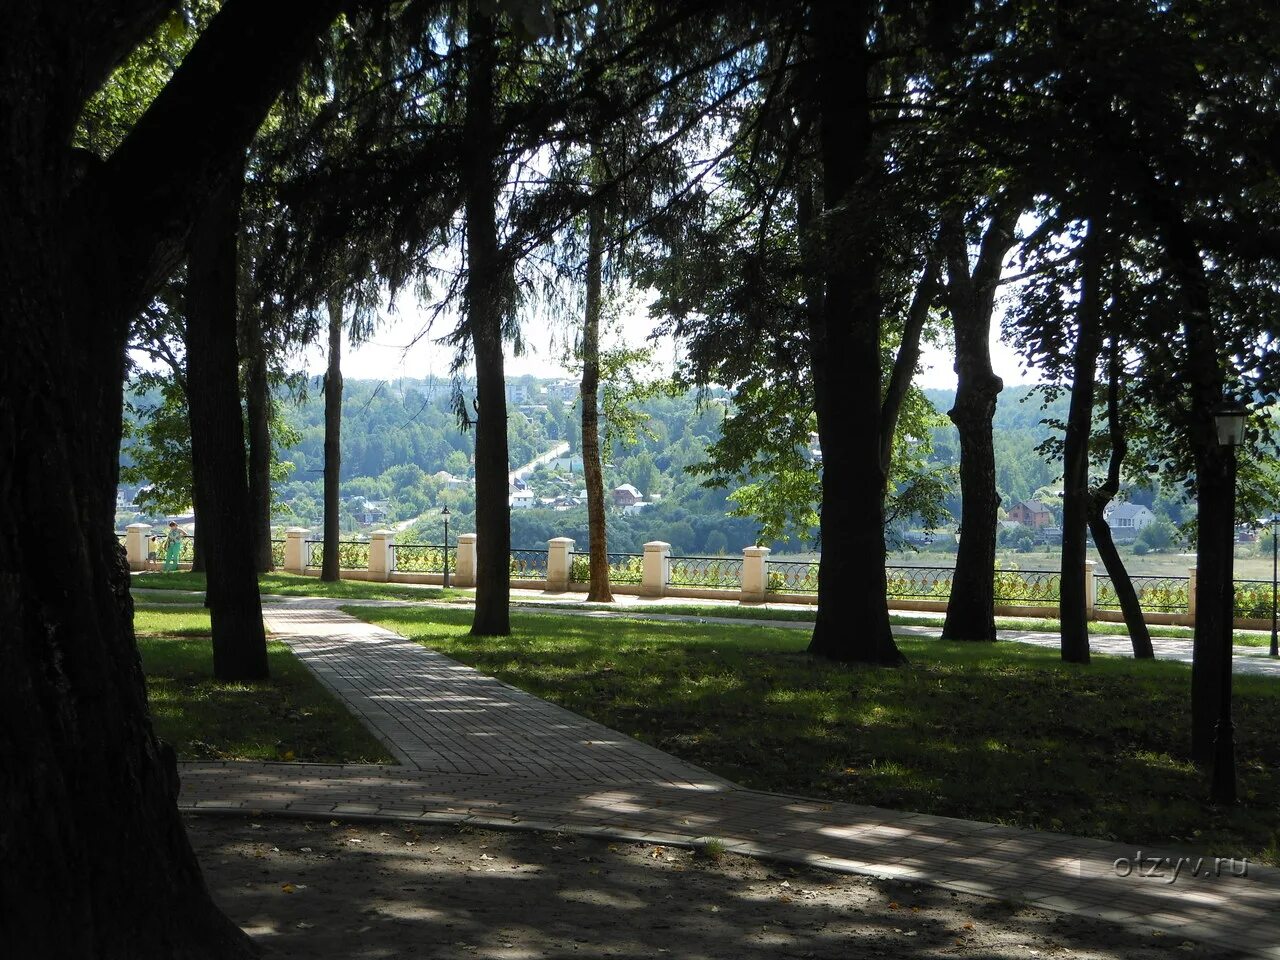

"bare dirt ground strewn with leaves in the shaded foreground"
[187,815,1236,960]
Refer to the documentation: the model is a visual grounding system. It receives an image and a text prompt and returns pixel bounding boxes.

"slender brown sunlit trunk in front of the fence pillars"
[581,200,613,603]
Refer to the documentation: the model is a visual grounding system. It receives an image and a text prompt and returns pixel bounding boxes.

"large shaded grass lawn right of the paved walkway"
[349,607,1280,864]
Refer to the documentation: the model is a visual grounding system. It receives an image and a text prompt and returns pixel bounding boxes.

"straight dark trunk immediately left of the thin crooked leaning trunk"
[1059,216,1103,663]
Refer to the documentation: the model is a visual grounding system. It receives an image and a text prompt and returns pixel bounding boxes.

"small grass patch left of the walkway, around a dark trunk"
[133,611,394,763]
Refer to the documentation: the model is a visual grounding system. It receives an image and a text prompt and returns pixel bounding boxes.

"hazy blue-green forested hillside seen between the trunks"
[122,376,1218,554]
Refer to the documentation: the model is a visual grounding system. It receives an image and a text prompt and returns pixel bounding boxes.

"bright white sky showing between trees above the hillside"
[303,296,1037,389]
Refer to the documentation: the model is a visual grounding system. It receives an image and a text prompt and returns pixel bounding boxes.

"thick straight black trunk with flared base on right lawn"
[809,1,904,664]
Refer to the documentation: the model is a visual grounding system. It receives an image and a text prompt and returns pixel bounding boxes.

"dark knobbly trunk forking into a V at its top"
[941,210,1018,640]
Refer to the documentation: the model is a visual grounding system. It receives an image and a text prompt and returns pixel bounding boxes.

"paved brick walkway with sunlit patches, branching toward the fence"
[179,600,1280,960]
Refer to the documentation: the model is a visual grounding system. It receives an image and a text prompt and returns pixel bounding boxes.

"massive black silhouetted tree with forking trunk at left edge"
[0,0,337,957]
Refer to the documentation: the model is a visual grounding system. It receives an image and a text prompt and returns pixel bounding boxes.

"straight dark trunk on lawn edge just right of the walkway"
[463,9,511,636]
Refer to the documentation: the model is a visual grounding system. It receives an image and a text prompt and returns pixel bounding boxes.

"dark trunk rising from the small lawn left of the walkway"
[187,163,269,681]
